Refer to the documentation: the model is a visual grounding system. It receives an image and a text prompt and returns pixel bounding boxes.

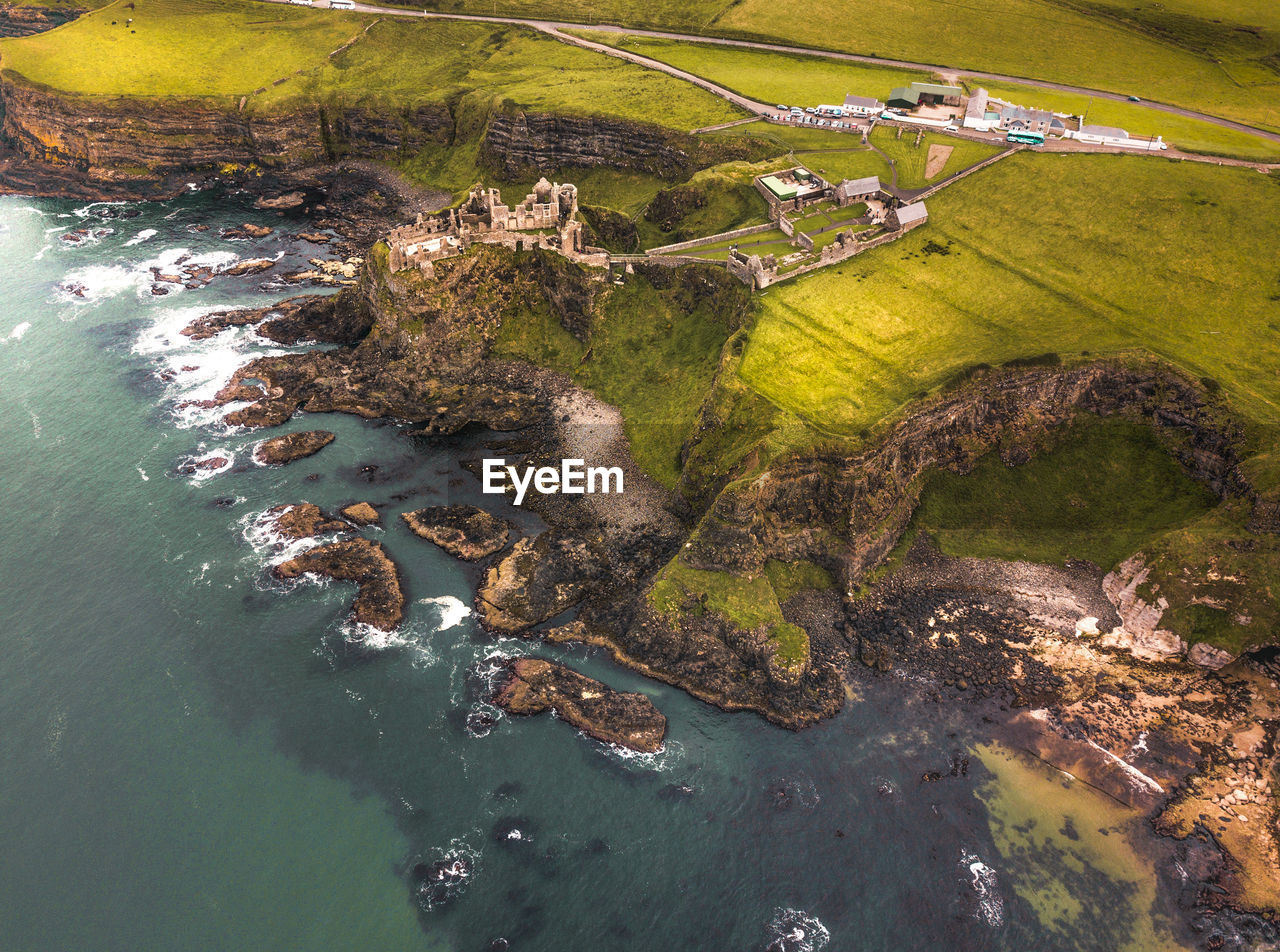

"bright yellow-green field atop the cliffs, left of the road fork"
[0,0,741,129]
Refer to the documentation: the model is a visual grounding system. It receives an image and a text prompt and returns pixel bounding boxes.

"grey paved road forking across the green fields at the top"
[265,0,1280,170]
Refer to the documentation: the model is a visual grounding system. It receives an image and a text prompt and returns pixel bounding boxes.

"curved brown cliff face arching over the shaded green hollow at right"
[685,362,1248,583]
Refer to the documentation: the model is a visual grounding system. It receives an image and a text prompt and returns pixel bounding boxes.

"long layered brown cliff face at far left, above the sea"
[0,78,452,188]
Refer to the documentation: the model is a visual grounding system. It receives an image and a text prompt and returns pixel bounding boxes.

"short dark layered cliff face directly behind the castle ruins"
[483,113,756,178]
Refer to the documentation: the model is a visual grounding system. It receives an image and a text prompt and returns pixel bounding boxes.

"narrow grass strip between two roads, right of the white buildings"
[969,82,1280,163]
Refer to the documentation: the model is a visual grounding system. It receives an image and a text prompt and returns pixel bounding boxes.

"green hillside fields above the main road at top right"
[399,0,1280,129]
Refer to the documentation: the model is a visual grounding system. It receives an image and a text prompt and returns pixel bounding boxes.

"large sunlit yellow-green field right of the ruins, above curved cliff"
[741,154,1280,435]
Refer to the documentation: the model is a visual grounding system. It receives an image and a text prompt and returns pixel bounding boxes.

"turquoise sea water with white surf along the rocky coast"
[0,189,1192,952]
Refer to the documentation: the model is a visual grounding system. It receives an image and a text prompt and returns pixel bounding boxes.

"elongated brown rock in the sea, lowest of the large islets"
[494,658,667,754]
